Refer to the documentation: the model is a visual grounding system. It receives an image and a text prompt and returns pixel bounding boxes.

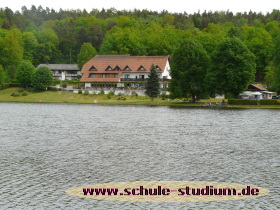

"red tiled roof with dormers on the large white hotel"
[81,55,169,82]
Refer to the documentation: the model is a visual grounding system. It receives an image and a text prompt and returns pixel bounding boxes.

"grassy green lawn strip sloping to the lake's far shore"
[0,88,280,109]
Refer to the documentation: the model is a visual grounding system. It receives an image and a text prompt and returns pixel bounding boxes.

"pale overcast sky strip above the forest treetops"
[0,0,280,13]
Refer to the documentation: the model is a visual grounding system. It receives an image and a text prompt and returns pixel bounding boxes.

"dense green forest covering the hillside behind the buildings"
[0,6,280,90]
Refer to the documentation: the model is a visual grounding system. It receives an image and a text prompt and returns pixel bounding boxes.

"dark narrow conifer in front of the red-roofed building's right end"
[145,65,160,101]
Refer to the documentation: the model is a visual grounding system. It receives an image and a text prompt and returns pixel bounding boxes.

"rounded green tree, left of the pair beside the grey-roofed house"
[16,61,35,88]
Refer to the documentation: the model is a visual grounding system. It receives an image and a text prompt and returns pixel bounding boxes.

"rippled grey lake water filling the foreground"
[0,103,280,209]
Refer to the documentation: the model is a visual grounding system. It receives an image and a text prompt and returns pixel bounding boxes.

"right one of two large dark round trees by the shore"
[208,38,256,97]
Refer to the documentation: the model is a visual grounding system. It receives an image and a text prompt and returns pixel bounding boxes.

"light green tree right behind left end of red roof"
[78,43,97,69]
